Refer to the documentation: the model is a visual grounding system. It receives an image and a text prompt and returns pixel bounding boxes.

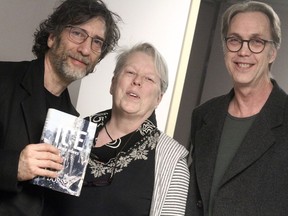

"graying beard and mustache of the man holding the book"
[49,38,97,83]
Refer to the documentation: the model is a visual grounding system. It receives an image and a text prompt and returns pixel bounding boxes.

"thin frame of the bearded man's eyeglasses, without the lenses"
[65,25,108,53]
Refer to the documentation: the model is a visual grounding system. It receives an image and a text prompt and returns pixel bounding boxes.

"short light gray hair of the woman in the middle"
[114,43,168,94]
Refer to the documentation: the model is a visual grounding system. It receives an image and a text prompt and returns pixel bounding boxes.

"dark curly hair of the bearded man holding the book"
[32,0,121,62]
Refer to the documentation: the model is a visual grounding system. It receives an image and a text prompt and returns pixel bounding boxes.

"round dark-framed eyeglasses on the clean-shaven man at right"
[225,37,274,54]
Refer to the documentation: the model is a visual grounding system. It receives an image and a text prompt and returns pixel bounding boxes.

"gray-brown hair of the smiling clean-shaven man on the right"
[221,1,281,49]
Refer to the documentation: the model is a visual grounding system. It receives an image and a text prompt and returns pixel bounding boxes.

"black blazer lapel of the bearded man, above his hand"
[21,59,46,143]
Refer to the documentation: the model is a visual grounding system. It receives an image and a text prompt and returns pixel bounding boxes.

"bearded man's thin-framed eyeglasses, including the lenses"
[66,25,107,53]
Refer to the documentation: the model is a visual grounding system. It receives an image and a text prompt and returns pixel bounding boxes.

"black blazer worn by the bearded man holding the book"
[0,59,79,216]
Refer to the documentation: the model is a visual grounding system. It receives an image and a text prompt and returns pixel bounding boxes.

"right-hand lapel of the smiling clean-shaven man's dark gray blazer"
[220,80,287,185]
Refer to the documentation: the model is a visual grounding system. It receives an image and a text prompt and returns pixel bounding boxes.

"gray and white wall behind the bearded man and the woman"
[0,0,195,131]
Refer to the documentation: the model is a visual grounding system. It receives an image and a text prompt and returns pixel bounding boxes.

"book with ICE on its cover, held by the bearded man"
[32,108,97,196]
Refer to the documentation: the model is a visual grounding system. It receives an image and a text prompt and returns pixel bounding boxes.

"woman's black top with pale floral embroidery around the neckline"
[46,110,160,216]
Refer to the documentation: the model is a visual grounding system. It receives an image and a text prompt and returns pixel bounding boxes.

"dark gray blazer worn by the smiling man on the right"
[186,80,288,216]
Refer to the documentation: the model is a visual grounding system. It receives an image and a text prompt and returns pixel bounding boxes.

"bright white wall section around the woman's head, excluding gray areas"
[76,0,192,131]
